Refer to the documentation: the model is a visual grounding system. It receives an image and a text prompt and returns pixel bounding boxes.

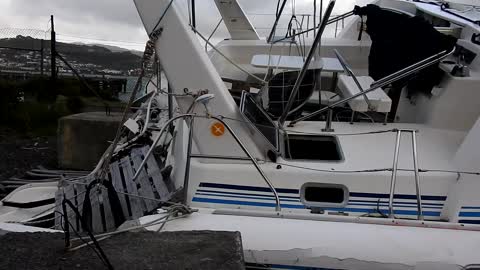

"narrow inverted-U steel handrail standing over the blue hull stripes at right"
[388,129,423,220]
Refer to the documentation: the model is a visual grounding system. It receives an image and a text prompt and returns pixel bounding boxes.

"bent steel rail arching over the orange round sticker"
[132,113,281,211]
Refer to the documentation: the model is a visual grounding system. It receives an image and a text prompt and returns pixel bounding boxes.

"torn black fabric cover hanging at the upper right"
[354,4,457,95]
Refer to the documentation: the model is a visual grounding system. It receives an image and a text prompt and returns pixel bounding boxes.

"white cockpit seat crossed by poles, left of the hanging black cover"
[338,74,392,113]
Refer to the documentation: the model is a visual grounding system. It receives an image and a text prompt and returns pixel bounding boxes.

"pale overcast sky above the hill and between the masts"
[0,0,354,50]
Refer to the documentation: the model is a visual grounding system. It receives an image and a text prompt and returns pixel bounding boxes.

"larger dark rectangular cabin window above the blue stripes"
[284,134,343,162]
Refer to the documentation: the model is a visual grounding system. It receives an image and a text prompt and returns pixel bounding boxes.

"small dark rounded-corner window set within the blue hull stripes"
[300,183,349,208]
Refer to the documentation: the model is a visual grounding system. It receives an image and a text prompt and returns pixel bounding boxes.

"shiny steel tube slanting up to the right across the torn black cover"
[289,48,455,126]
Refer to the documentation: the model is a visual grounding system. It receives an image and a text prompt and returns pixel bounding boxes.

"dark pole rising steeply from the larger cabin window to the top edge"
[278,0,335,126]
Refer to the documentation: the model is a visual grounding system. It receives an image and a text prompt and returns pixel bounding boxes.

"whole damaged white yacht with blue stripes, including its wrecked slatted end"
[3,0,480,270]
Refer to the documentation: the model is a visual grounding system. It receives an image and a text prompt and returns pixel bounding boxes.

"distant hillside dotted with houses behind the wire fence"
[0,36,146,75]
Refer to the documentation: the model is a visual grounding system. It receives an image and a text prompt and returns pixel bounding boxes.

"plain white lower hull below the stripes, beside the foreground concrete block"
[140,209,480,269]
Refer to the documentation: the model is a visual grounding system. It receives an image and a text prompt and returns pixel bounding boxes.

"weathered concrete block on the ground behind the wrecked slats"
[57,112,122,170]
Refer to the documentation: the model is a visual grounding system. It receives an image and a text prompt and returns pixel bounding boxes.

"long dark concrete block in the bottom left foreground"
[0,231,245,270]
